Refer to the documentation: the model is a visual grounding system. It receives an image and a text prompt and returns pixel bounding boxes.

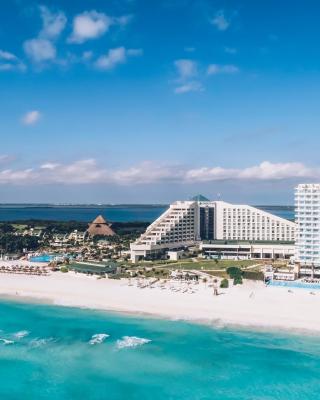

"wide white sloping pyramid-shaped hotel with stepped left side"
[131,200,296,262]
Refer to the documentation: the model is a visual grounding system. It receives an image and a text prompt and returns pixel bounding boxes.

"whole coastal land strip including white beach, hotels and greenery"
[0,185,320,338]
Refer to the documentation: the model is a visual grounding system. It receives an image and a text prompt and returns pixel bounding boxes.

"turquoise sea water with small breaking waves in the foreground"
[0,301,320,400]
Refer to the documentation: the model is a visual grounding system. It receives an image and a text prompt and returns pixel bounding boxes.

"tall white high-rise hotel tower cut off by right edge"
[295,184,320,272]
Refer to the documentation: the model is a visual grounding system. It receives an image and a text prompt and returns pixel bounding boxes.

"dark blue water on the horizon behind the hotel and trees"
[0,205,294,222]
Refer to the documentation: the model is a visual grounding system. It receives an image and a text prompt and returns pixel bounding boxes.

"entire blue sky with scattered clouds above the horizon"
[0,0,320,204]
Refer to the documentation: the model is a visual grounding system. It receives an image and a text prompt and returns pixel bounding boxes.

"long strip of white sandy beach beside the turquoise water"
[0,272,320,333]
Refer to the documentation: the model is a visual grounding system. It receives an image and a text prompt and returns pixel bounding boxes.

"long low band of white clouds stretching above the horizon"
[0,159,320,185]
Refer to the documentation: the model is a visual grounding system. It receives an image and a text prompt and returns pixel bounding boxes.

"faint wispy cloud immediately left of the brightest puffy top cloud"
[39,6,67,39]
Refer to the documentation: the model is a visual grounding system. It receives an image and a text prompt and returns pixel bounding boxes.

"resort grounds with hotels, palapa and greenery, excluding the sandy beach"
[0,184,320,280]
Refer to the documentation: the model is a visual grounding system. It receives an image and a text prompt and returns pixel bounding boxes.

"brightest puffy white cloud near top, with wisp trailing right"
[68,10,127,44]
